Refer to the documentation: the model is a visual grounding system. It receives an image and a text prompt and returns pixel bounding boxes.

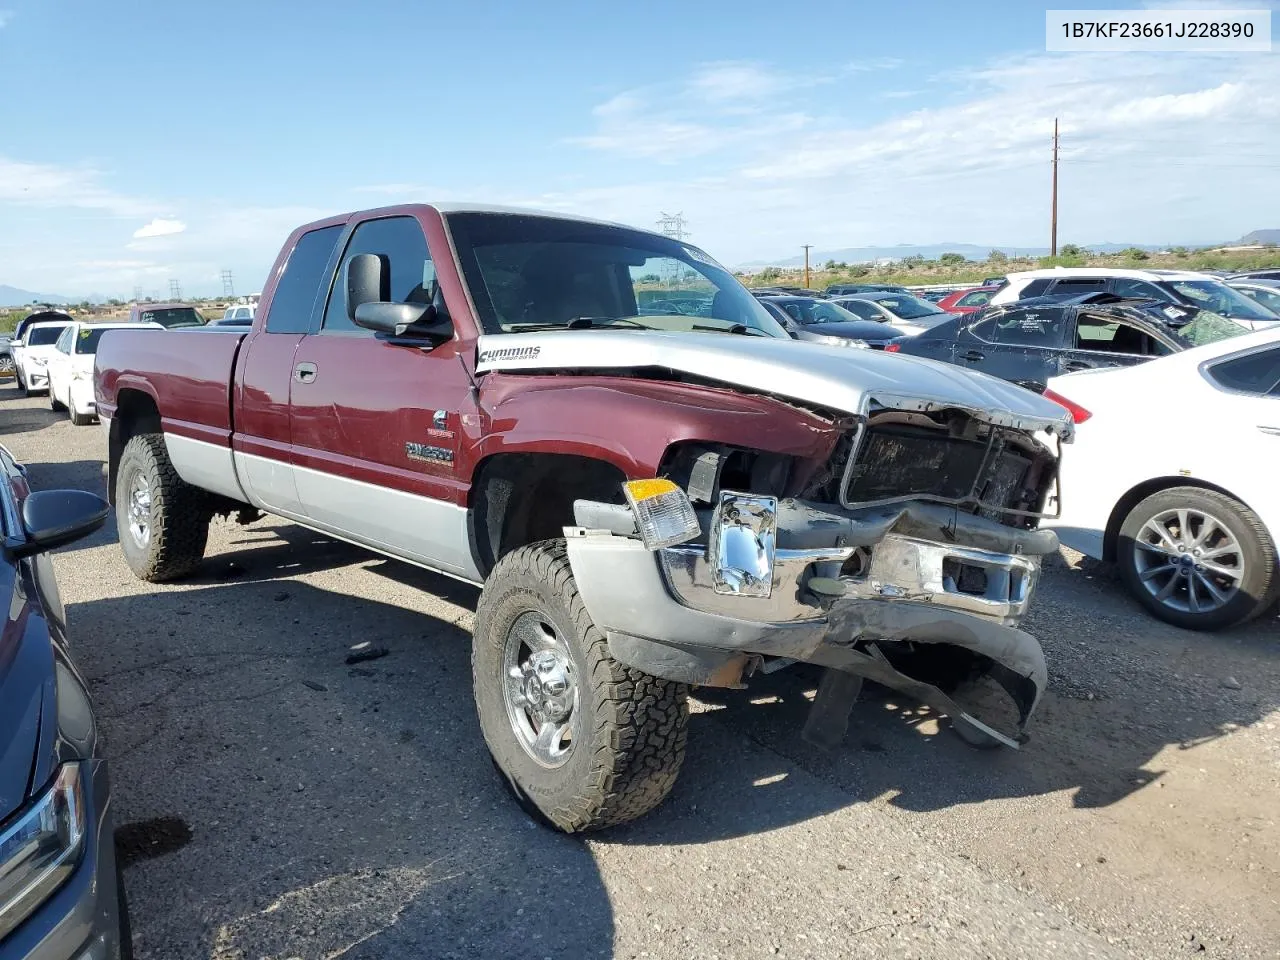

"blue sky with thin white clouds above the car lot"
[0,0,1280,296]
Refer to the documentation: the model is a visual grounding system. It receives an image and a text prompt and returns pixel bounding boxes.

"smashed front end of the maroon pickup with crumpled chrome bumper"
[566,393,1071,746]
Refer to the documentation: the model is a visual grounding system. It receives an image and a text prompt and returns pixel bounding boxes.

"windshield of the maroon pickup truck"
[447,214,790,339]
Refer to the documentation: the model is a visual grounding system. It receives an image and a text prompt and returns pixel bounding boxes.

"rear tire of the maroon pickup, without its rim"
[115,434,211,584]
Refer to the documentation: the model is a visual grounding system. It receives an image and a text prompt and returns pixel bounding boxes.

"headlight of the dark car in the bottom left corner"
[0,763,86,941]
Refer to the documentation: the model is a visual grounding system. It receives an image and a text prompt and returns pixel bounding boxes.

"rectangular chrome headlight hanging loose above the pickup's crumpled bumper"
[708,490,778,596]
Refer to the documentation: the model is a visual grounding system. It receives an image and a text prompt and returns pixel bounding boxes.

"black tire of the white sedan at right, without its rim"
[1116,486,1280,630]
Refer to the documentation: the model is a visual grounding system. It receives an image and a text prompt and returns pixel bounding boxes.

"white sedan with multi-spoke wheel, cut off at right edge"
[1044,329,1280,630]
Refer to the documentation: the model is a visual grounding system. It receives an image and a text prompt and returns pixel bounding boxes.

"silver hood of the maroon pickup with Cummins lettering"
[476,330,1073,439]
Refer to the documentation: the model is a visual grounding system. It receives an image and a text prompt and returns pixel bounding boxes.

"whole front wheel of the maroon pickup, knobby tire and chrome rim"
[471,540,689,833]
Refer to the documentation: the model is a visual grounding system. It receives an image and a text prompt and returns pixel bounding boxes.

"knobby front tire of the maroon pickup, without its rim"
[471,540,689,833]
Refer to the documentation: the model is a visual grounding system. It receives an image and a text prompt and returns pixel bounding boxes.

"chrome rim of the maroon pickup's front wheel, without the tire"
[502,611,580,767]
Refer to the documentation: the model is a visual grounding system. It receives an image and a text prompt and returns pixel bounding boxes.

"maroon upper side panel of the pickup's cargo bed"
[93,328,248,447]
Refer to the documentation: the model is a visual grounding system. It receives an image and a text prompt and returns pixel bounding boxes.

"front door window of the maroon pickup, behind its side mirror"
[320,216,434,337]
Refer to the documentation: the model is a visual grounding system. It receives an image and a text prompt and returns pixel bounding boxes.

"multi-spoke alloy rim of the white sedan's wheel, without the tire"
[1133,508,1245,613]
